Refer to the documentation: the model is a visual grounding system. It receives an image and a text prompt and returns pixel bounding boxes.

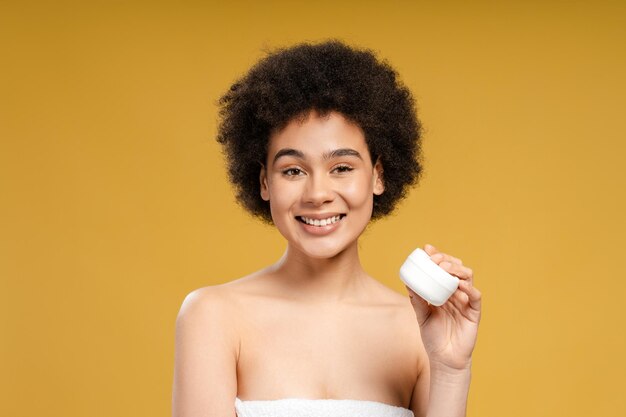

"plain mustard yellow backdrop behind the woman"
[0,0,626,417]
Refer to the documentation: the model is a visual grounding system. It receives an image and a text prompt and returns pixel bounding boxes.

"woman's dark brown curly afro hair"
[217,40,422,223]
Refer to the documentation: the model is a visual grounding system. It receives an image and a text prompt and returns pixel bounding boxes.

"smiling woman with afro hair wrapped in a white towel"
[173,41,480,417]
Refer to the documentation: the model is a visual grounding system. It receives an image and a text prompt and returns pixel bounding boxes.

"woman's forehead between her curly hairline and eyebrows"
[267,111,369,161]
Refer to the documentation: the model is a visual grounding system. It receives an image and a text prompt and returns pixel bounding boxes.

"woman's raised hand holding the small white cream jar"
[407,245,481,370]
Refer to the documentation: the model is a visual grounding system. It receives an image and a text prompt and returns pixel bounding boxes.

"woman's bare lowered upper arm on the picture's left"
[172,287,239,417]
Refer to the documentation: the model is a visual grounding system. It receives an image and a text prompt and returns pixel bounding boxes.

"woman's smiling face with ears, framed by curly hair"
[260,112,384,258]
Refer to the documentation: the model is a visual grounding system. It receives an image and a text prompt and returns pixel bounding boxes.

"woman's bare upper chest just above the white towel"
[238,307,419,404]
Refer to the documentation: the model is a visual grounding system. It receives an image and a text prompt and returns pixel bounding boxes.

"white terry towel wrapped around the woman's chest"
[235,398,414,417]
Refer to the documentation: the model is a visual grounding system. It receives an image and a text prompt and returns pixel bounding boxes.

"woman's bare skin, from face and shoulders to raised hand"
[173,112,480,417]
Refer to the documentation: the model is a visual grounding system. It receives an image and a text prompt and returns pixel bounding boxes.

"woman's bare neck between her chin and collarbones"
[274,242,369,302]
